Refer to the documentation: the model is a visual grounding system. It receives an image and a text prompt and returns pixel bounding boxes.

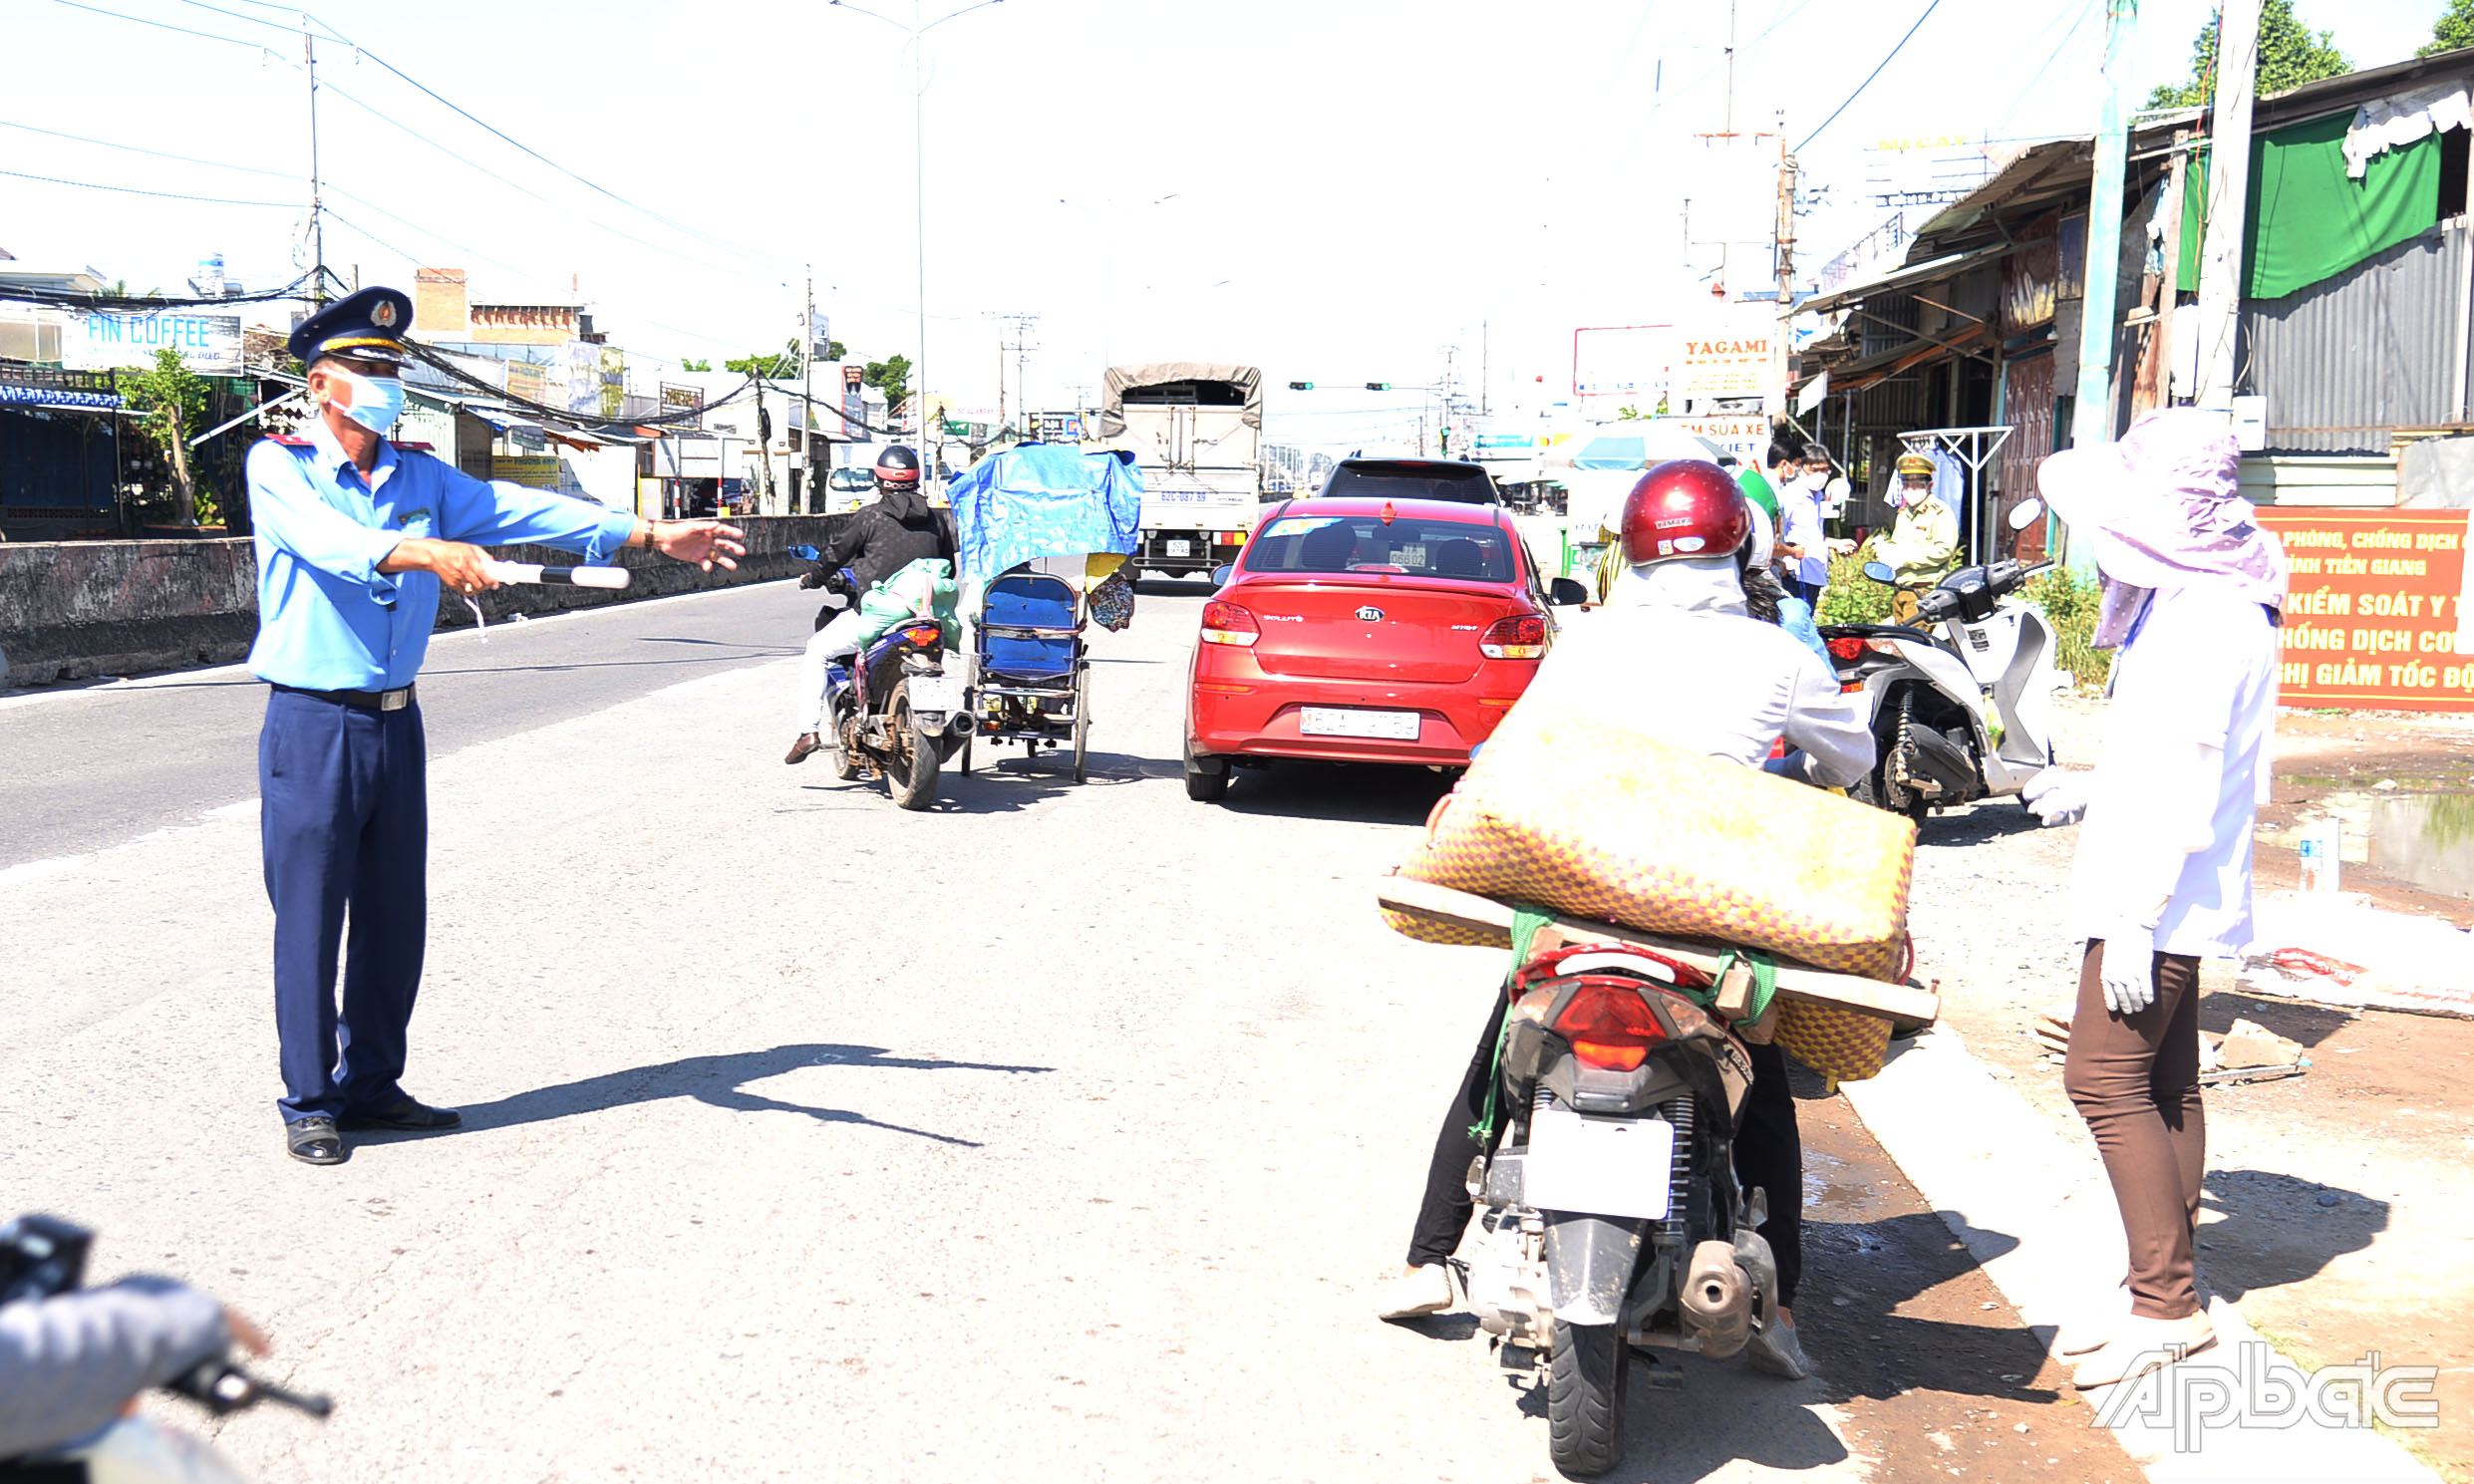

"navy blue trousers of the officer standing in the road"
[257,690,431,1123]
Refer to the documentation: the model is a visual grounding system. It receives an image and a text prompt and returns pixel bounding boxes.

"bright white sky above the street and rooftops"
[0,0,2442,443]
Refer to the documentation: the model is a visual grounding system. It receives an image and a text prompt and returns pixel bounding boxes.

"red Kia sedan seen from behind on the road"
[1185,497,1583,801]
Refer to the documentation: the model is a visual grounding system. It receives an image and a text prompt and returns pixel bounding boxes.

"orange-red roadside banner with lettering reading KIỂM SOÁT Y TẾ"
[2259,507,2474,710]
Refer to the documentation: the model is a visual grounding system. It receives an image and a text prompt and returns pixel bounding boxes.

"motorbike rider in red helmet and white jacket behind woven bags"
[1378,460,1875,1380]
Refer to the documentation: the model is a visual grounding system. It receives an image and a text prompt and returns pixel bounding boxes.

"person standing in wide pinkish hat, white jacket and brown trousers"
[2023,408,2286,1387]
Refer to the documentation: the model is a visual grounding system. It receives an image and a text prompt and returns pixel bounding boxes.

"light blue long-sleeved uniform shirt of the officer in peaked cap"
[250,418,636,690]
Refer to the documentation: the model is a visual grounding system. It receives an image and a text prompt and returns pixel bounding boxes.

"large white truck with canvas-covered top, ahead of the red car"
[1098,361,1262,576]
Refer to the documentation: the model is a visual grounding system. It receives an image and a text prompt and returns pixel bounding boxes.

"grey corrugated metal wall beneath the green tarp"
[2242,227,2467,452]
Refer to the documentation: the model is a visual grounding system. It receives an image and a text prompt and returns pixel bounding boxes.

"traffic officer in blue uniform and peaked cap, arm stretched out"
[247,289,748,1165]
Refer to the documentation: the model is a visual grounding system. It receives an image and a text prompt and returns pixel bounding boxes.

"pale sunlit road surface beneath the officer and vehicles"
[0,576,2135,1484]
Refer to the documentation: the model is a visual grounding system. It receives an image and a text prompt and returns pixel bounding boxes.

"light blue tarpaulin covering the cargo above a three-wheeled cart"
[945,443,1143,581]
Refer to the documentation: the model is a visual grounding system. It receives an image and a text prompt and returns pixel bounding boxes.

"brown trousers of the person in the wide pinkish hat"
[2061,940,2207,1319]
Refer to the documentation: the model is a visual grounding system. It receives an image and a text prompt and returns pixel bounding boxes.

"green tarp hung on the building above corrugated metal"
[2175,112,2439,299]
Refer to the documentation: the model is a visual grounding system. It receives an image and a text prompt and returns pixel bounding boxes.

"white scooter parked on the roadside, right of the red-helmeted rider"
[1821,499,2058,823]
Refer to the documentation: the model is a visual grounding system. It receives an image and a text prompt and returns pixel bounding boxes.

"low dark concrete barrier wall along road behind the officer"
[0,514,824,685]
